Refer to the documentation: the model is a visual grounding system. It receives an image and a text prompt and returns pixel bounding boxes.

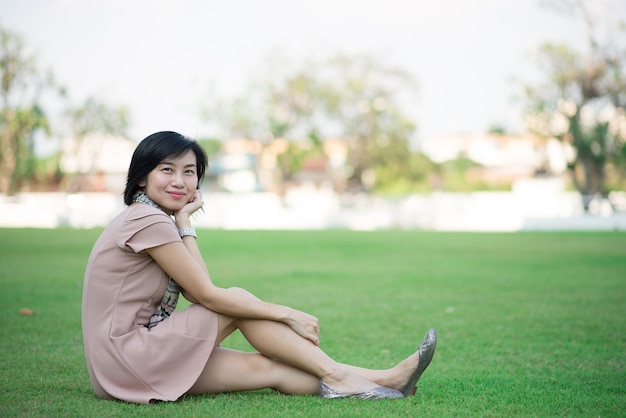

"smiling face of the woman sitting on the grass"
[139,150,198,214]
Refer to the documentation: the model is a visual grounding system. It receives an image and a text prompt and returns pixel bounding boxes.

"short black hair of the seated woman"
[124,131,208,205]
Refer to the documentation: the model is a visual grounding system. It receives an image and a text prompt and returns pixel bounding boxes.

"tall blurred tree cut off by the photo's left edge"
[0,26,63,195]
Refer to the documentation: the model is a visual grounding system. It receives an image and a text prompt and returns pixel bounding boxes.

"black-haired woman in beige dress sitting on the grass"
[82,132,436,403]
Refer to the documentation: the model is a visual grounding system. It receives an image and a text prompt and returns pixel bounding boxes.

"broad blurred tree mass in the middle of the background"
[204,55,421,192]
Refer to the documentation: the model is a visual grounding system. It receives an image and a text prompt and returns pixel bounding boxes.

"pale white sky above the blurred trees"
[0,0,626,148]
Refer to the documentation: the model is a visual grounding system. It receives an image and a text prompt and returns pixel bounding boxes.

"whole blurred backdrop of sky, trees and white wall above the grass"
[0,0,626,231]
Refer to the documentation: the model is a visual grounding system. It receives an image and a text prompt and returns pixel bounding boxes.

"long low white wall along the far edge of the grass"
[0,182,626,231]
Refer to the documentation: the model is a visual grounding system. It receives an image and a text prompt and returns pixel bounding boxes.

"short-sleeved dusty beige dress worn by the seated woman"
[82,204,217,403]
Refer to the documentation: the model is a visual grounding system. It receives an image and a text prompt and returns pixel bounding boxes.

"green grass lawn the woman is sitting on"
[0,229,626,417]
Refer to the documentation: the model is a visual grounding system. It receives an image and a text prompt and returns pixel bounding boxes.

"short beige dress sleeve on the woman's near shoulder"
[120,205,182,253]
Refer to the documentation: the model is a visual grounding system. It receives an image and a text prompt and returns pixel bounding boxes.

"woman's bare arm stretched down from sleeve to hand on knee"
[146,242,319,345]
